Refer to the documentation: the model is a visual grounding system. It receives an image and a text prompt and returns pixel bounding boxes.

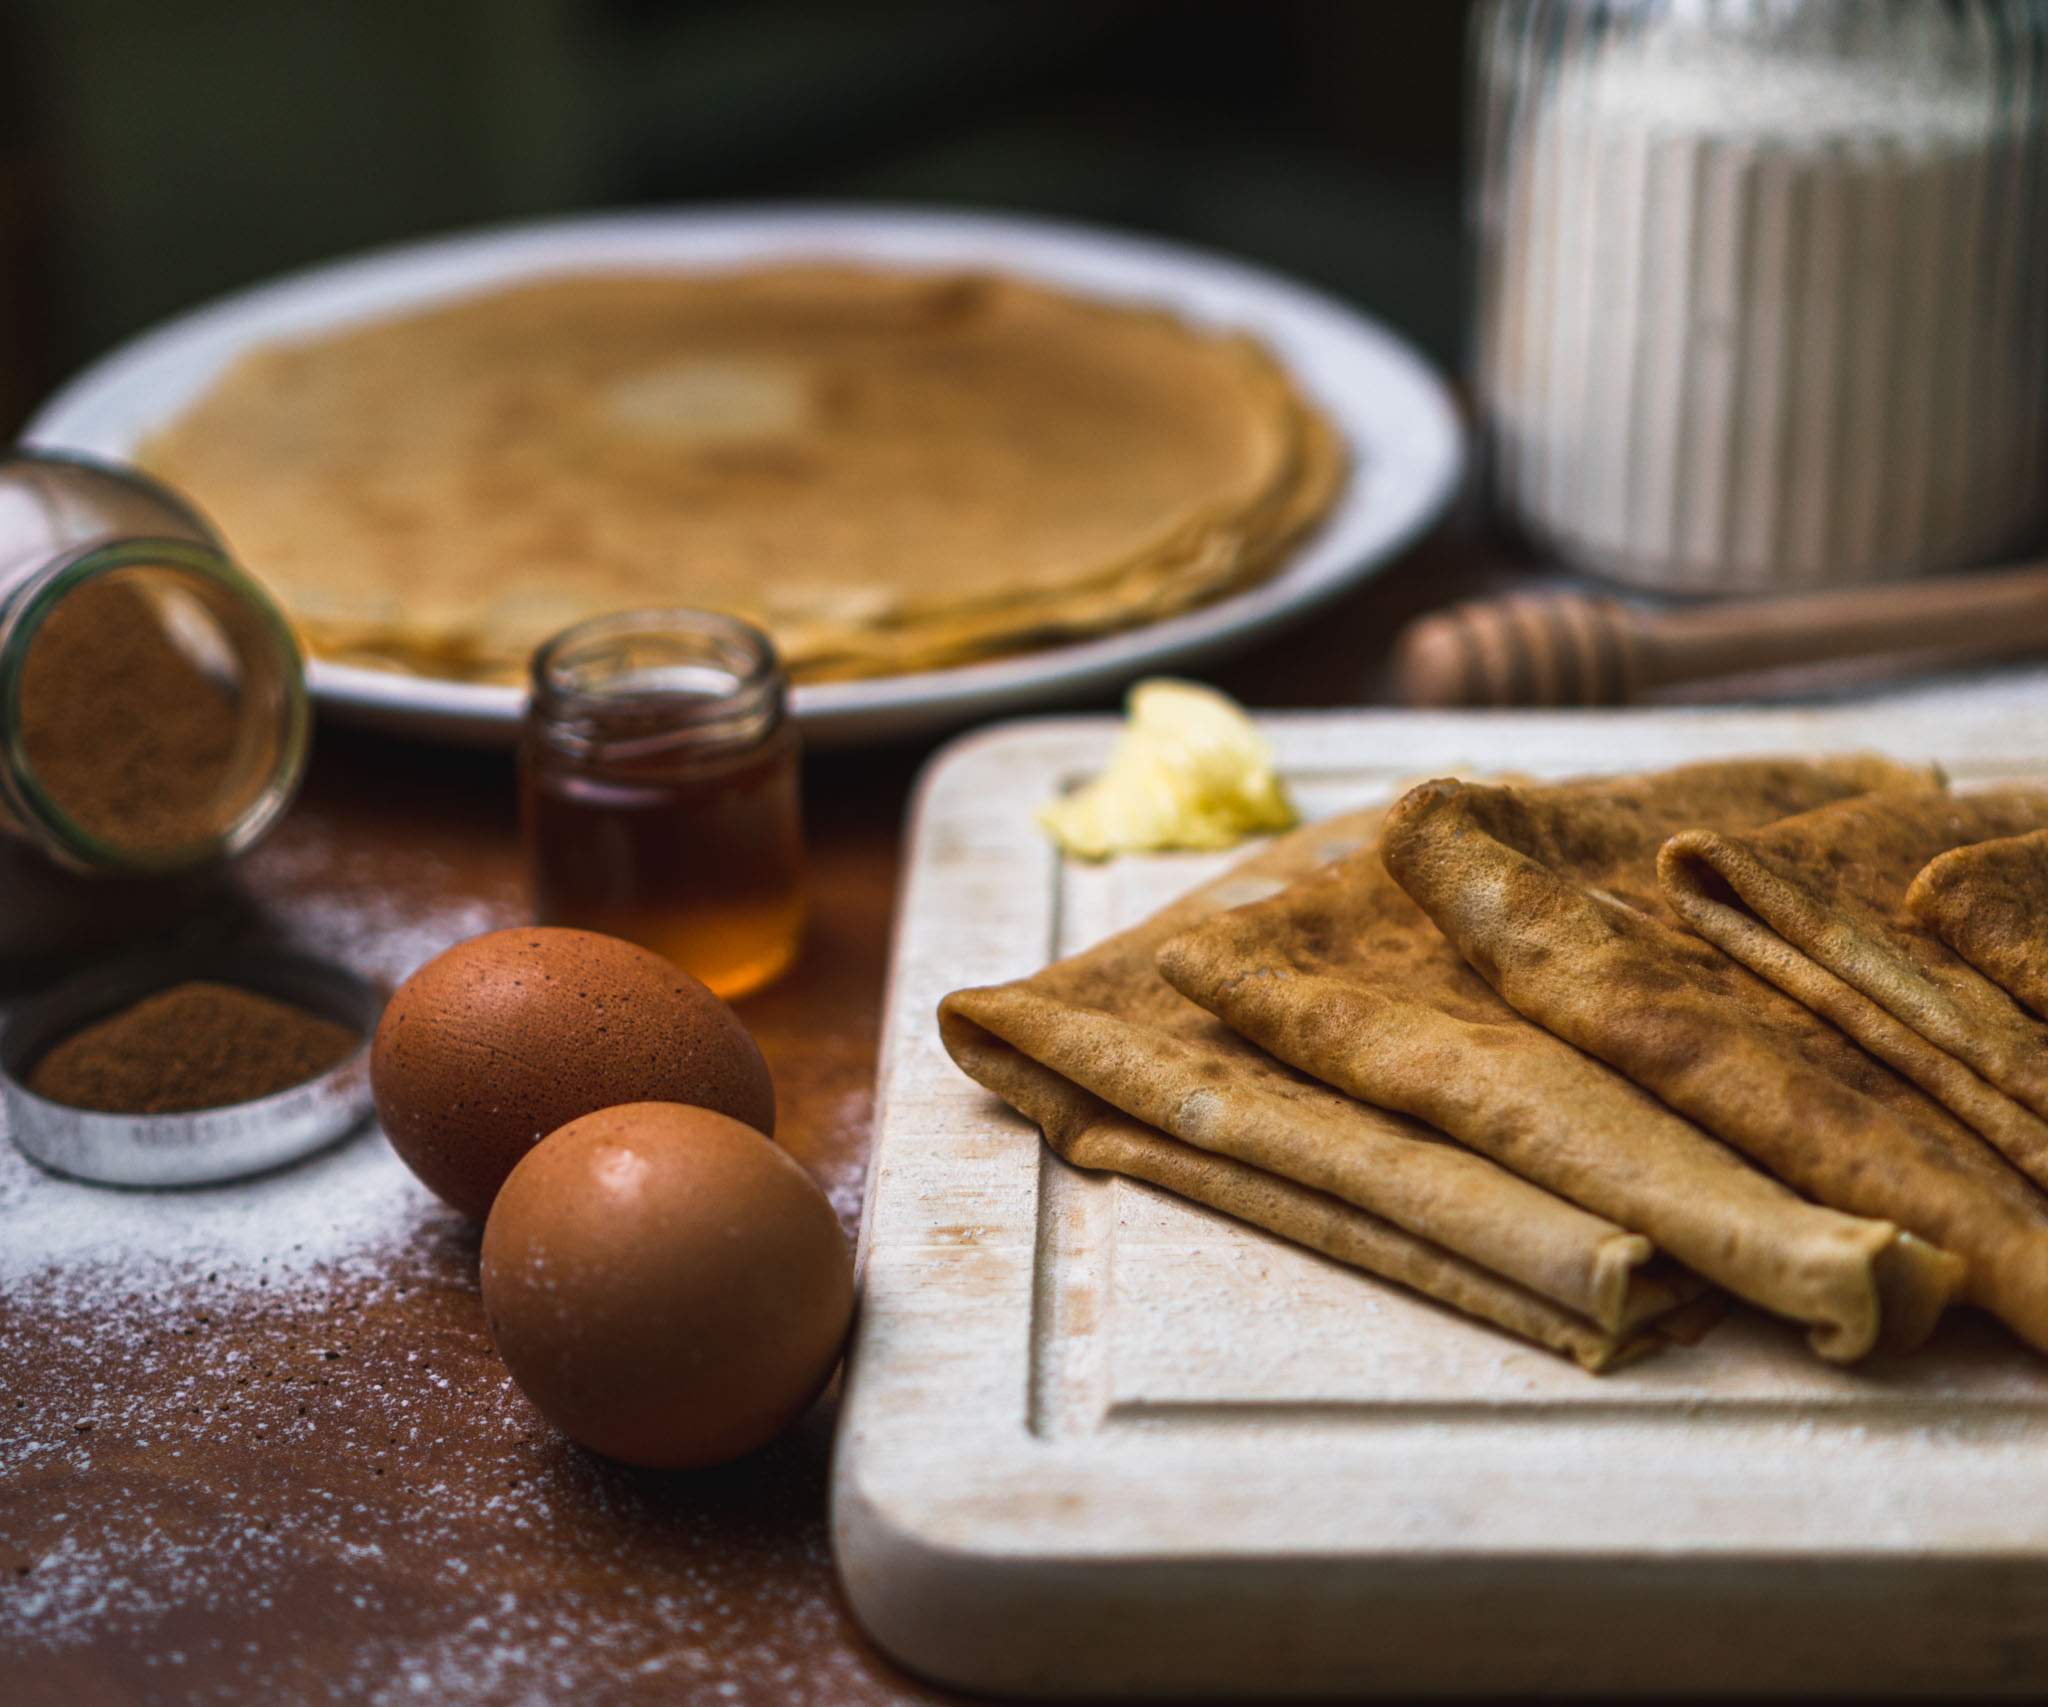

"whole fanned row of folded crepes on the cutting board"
[940,758,2048,1369]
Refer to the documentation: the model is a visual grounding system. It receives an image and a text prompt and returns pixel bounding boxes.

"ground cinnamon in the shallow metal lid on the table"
[29,980,362,1115]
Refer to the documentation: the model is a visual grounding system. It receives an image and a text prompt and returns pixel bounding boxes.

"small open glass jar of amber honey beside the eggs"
[520,611,803,996]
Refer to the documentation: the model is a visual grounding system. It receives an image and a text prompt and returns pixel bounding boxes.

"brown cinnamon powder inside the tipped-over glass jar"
[20,580,246,855]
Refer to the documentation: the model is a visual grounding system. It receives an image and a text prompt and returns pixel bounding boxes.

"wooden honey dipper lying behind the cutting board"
[1393,564,2048,705]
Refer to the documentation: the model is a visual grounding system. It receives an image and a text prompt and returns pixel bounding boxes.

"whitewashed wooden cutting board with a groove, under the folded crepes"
[834,701,2048,1695]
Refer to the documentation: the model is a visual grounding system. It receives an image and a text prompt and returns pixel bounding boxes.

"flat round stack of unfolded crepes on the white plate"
[141,264,1343,680]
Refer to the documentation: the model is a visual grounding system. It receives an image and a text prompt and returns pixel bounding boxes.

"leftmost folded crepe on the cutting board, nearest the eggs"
[940,811,1700,1369]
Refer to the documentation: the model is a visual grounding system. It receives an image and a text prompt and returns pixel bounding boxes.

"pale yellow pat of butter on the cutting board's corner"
[1038,680,1298,859]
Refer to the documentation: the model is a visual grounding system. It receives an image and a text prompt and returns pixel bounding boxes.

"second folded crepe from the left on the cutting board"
[1159,762,1962,1361]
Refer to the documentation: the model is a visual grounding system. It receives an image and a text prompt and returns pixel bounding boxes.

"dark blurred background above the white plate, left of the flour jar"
[0,0,1468,430]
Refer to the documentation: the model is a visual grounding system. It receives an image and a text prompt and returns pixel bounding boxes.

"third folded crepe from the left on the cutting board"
[1380,762,2048,1348]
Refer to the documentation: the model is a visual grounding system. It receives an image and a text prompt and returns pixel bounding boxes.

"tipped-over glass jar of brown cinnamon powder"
[0,451,309,877]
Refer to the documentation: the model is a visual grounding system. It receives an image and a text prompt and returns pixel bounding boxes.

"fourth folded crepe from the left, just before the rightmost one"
[1657,789,2048,1184]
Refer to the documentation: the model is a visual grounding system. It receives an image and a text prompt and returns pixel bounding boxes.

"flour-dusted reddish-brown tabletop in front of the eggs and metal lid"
[0,1129,897,1703]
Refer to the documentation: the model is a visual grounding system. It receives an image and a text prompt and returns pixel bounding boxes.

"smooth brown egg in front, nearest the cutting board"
[483,1102,854,1469]
